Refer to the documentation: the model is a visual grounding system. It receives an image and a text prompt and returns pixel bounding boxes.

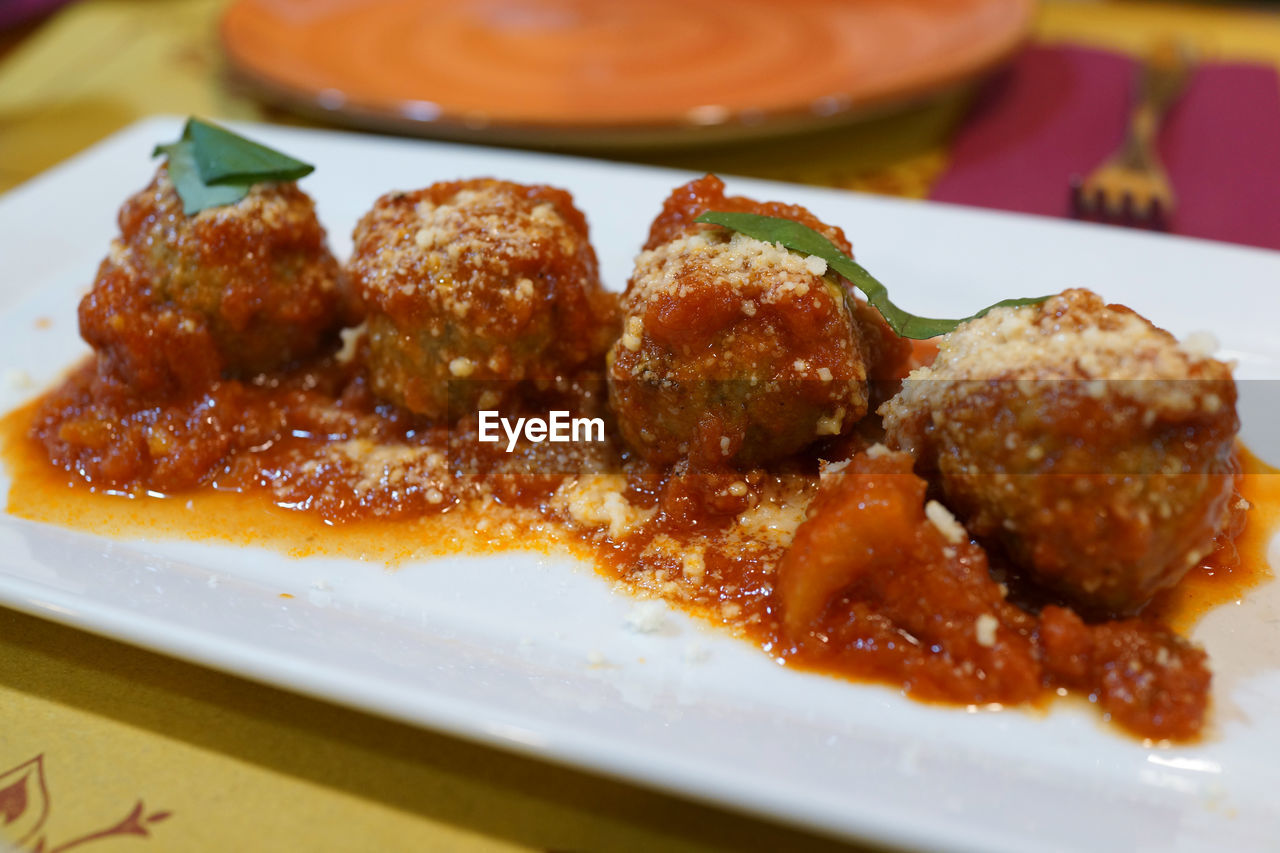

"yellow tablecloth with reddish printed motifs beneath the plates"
[0,0,1280,853]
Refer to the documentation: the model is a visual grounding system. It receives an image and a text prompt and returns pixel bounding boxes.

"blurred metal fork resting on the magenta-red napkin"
[1071,42,1194,229]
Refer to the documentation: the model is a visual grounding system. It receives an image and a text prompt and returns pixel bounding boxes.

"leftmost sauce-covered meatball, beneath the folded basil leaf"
[79,167,348,392]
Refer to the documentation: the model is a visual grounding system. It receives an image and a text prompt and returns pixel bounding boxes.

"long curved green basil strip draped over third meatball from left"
[694,210,1048,341]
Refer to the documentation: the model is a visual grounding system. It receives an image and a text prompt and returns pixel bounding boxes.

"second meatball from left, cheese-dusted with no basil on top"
[349,178,617,418]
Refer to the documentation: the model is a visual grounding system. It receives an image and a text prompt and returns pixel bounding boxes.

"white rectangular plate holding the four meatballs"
[0,118,1280,850]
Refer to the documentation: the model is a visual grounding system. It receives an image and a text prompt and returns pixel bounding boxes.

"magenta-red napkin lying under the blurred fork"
[931,46,1280,248]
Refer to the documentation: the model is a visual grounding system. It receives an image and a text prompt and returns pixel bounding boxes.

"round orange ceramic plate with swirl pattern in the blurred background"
[223,0,1034,145]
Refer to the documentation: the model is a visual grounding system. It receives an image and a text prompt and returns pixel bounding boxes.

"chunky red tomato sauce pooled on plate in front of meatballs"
[3,360,1280,739]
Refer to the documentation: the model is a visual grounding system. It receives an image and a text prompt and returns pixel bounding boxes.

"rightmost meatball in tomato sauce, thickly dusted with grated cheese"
[881,289,1239,612]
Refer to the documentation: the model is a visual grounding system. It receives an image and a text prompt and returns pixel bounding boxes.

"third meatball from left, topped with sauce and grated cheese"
[608,175,902,466]
